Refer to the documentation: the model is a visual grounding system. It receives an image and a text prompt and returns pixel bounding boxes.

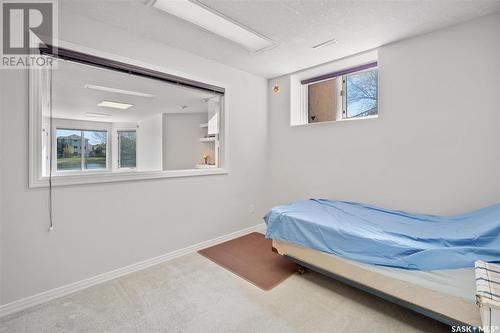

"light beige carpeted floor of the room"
[0,250,450,333]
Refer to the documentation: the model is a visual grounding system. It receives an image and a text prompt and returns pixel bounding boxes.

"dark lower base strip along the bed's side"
[283,255,470,326]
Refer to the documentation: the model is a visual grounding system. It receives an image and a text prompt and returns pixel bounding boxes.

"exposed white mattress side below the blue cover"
[350,259,476,301]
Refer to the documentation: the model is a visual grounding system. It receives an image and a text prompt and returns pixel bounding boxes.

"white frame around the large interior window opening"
[28,41,229,188]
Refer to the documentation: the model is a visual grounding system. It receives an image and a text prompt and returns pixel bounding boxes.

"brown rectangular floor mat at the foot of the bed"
[198,232,297,290]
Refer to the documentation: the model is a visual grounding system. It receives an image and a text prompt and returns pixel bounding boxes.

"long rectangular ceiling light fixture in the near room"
[152,0,276,52]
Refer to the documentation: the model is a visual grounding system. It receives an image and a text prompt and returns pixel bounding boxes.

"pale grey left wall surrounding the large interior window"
[0,12,267,304]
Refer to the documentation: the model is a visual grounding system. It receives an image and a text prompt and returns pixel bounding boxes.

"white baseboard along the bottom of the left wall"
[0,223,266,318]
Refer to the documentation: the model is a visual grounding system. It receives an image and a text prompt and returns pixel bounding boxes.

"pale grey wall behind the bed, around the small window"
[269,15,500,214]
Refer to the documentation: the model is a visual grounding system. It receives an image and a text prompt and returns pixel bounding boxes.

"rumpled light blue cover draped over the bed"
[264,199,500,270]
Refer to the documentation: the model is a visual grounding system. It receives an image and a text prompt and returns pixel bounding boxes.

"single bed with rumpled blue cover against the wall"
[264,199,500,326]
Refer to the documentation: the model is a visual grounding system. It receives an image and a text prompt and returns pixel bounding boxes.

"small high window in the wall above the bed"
[301,62,378,124]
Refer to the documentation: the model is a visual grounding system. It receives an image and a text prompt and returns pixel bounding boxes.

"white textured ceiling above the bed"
[60,0,500,78]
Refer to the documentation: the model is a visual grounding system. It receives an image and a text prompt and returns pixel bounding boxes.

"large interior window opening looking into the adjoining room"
[32,51,224,184]
